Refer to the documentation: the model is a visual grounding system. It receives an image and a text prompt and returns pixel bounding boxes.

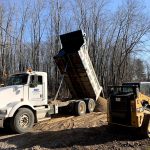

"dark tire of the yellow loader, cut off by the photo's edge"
[141,114,150,138]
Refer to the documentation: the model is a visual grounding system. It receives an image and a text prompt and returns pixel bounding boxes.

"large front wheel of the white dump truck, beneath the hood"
[11,108,34,133]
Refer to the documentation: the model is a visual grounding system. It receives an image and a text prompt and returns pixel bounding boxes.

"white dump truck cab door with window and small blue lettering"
[29,75,43,101]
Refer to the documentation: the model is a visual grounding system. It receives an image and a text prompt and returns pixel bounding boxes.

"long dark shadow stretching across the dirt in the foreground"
[0,125,148,149]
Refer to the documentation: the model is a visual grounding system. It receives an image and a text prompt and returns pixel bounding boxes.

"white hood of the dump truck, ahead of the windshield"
[0,85,24,108]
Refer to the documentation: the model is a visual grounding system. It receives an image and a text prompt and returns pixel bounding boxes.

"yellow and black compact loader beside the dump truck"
[107,82,150,136]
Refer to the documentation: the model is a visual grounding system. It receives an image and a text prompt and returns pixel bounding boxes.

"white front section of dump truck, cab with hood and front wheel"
[0,70,51,133]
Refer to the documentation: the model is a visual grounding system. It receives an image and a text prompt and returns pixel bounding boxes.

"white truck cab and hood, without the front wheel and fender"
[0,71,47,107]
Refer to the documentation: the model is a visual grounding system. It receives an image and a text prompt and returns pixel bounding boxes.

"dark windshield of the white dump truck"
[6,74,28,86]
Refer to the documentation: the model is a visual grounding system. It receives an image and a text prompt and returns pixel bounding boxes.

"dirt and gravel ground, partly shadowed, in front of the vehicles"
[0,112,150,150]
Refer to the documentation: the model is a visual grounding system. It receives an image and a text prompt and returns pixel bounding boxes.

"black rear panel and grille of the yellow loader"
[109,86,136,126]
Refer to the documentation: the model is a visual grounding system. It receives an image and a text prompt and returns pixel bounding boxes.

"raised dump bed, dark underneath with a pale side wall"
[54,30,102,100]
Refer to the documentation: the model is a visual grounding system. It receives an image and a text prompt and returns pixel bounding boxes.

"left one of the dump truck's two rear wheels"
[75,101,86,116]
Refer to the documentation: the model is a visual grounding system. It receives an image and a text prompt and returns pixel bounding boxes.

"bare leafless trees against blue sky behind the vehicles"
[0,0,150,96]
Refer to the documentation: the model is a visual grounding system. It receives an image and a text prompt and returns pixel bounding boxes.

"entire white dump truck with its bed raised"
[0,30,102,133]
